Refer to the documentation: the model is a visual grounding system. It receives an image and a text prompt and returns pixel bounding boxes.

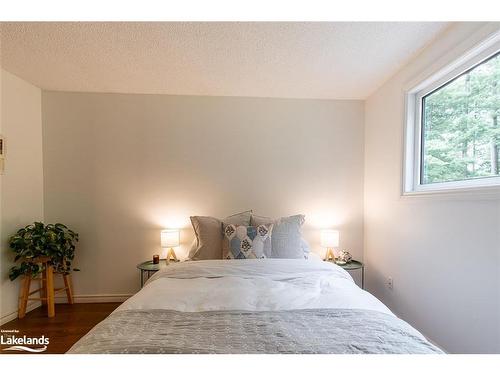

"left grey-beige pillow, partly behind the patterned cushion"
[188,211,252,260]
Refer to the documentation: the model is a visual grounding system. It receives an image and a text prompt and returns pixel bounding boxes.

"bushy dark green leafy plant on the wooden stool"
[9,222,79,280]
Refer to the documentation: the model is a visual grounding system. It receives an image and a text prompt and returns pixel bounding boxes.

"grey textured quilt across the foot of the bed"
[68,309,442,354]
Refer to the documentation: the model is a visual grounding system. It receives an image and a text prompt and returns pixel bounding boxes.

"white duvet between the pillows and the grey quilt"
[116,259,392,315]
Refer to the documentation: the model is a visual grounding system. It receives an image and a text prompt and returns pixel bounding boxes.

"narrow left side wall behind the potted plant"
[0,70,43,321]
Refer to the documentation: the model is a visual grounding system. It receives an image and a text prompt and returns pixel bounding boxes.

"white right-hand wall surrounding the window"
[365,23,500,353]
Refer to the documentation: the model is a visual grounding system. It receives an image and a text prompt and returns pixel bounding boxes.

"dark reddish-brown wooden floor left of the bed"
[0,303,120,354]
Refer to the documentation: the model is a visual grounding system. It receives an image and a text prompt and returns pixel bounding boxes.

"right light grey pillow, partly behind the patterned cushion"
[250,215,309,259]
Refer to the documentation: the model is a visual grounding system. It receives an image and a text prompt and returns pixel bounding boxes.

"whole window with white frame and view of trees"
[404,35,500,192]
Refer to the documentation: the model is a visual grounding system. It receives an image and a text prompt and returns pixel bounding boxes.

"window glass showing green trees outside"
[423,55,500,183]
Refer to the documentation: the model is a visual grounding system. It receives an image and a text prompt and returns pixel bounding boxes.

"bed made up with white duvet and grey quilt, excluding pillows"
[68,259,442,354]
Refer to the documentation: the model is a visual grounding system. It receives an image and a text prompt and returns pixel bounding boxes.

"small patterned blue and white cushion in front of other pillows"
[222,223,273,259]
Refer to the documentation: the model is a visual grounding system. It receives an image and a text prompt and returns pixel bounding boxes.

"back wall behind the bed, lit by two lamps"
[42,91,364,300]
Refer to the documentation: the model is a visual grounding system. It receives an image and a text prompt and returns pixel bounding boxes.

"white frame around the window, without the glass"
[403,31,500,195]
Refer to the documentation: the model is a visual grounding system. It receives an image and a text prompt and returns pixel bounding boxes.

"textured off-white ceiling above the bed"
[1,22,447,99]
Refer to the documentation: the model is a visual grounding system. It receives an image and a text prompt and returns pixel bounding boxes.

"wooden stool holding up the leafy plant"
[18,257,73,319]
